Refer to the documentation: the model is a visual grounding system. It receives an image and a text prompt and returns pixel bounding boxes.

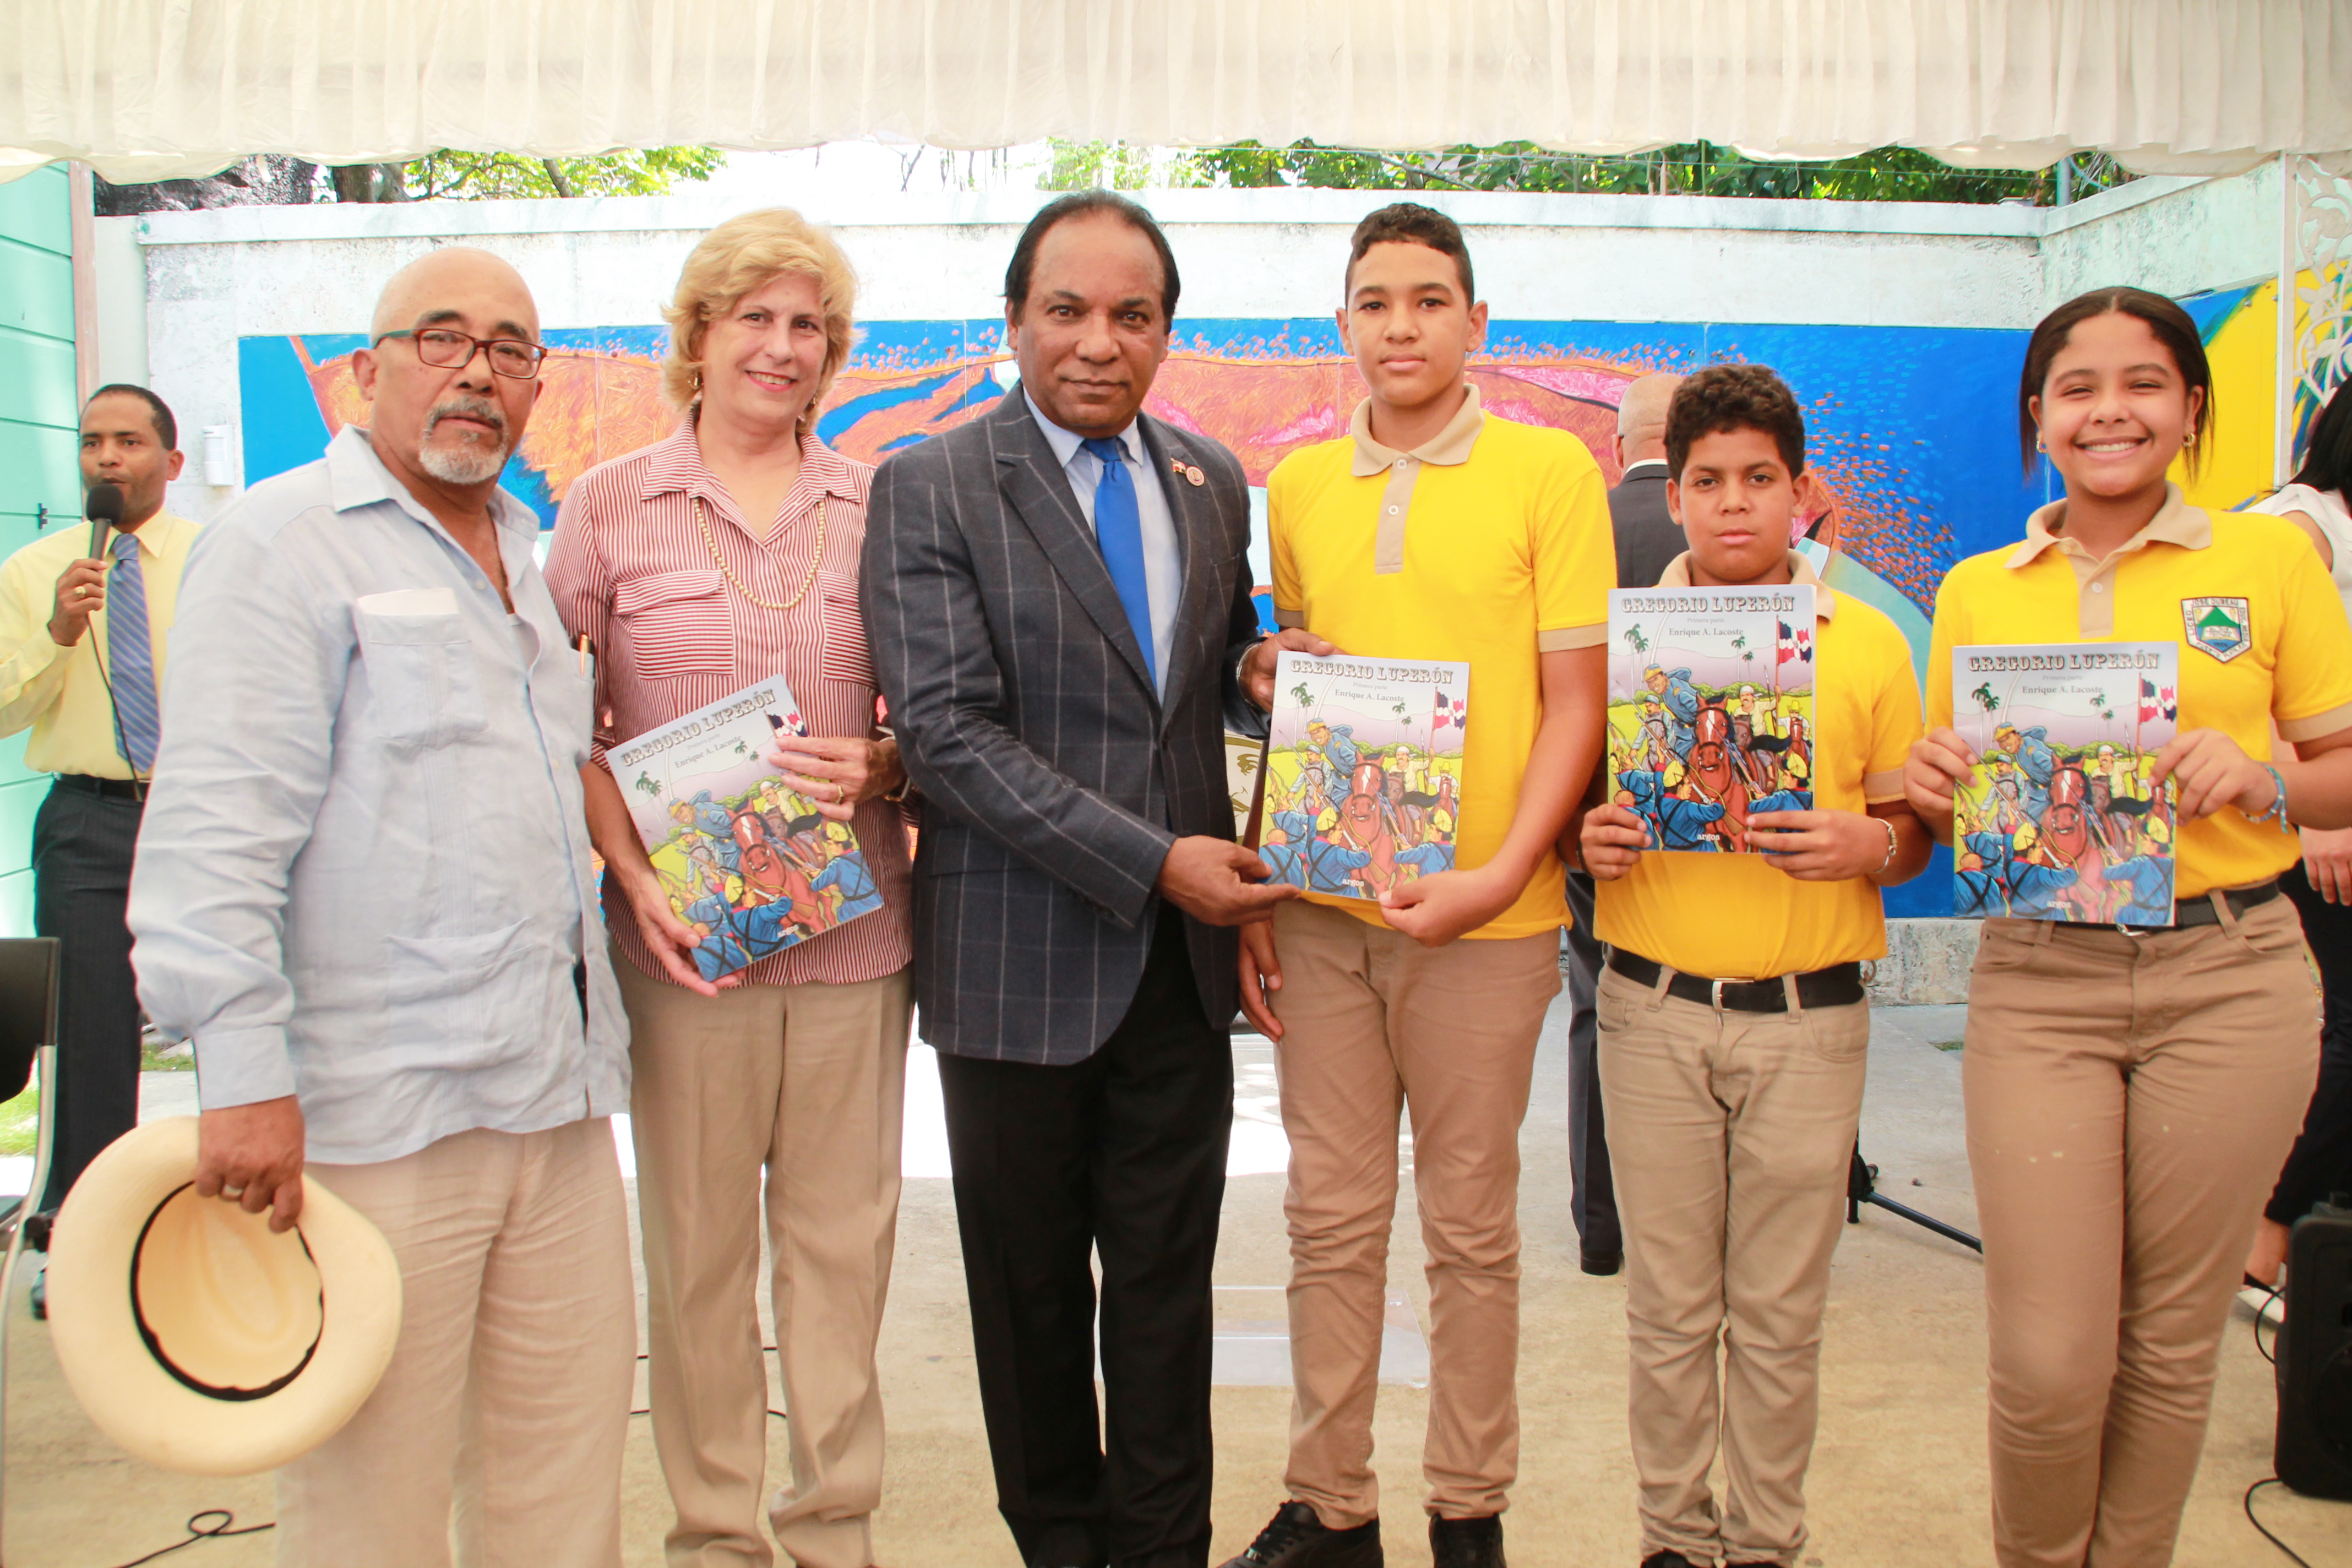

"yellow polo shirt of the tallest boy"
[1265,385,1616,938]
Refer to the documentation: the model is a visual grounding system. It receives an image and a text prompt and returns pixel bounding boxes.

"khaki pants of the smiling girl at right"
[1962,898,2319,1568]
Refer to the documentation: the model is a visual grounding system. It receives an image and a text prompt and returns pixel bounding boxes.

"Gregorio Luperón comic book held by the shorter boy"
[1609,583,1818,853]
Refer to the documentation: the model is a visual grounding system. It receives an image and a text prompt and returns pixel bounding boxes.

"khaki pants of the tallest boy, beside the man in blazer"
[1272,903,1559,1528]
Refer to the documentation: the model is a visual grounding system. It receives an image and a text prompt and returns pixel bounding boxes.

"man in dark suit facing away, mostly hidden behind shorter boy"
[1569,376,1684,1274]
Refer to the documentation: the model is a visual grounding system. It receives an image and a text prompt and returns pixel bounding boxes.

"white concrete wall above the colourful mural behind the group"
[99,190,2041,517]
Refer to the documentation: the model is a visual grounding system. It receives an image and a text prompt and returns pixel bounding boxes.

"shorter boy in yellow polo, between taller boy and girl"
[1583,364,1929,1568]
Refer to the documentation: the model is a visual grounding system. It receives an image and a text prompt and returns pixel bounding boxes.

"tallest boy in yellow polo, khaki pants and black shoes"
[1228,204,1616,1568]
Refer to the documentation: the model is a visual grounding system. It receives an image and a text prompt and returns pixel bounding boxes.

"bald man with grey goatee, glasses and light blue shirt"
[129,249,635,1568]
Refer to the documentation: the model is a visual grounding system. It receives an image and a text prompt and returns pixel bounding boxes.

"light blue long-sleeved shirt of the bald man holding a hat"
[129,426,628,1164]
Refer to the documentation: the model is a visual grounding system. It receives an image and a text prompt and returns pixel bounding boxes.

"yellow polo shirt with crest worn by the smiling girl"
[1926,484,2352,898]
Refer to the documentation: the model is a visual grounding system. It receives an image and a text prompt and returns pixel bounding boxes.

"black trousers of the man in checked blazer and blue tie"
[939,907,1233,1568]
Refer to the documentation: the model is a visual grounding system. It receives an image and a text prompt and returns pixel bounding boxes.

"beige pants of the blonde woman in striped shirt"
[614,959,913,1568]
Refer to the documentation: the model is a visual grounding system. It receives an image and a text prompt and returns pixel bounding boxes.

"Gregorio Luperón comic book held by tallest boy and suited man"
[1259,654,1470,898]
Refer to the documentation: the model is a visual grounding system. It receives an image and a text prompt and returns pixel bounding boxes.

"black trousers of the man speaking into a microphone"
[33,785,141,1208]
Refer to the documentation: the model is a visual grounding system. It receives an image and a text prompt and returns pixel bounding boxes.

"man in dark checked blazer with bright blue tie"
[863,190,1298,1568]
